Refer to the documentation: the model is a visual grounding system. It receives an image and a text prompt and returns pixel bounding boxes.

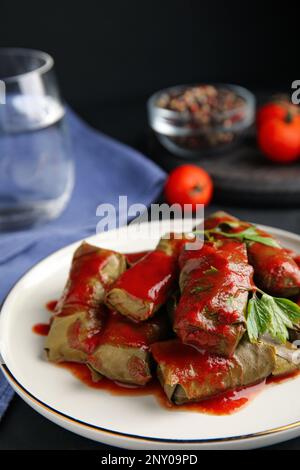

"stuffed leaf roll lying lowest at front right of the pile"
[151,339,275,405]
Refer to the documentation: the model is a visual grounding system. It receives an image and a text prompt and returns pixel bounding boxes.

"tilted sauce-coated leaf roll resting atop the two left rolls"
[105,236,183,322]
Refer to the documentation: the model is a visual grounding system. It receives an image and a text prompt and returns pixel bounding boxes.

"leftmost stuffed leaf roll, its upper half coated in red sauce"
[45,243,126,362]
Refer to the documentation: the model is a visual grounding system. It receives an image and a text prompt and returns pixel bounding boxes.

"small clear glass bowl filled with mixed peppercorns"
[148,84,255,158]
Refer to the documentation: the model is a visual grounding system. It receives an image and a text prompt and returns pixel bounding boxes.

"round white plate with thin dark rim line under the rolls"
[0,224,300,449]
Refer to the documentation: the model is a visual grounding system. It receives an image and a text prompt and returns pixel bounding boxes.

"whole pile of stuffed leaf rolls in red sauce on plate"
[46,217,300,405]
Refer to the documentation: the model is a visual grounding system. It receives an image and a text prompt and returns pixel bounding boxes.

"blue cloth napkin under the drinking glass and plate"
[0,109,165,418]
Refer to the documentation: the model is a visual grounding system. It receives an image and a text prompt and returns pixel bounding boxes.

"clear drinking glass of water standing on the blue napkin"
[0,48,74,230]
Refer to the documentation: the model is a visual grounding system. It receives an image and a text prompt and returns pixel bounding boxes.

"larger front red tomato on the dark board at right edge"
[258,113,300,163]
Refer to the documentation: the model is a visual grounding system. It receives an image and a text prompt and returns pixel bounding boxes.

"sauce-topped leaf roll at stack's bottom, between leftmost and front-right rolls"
[88,312,170,385]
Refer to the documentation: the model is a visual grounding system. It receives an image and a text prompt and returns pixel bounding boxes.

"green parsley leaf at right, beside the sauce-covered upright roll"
[247,290,300,343]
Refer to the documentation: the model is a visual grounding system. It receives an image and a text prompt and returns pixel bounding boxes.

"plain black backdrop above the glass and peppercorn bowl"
[0,0,299,106]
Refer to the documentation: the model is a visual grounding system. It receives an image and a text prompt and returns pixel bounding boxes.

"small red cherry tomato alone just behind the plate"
[165,165,213,210]
